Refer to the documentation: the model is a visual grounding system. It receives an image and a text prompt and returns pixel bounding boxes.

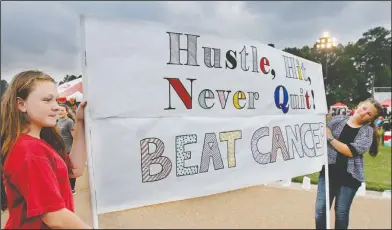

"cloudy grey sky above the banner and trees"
[1,1,391,81]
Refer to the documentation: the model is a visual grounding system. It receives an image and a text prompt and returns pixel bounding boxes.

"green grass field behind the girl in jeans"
[292,145,391,191]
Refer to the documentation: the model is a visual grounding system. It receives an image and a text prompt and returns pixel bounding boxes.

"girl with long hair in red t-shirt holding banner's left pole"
[1,71,91,229]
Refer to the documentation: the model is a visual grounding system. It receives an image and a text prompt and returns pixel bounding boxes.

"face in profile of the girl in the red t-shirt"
[18,81,60,128]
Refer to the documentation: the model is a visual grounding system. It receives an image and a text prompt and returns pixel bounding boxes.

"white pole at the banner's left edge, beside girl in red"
[79,14,98,229]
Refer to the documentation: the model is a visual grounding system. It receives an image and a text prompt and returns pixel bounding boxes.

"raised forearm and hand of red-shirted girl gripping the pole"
[69,102,87,177]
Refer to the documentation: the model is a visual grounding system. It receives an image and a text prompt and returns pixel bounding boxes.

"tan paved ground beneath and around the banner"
[1,168,391,229]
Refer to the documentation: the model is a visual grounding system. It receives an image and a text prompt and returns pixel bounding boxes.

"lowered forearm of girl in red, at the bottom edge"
[42,208,92,229]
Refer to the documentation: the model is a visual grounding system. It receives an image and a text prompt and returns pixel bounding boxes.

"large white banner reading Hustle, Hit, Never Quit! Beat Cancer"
[83,18,327,213]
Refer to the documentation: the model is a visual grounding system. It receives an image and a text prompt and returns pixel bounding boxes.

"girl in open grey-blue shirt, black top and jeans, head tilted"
[315,98,382,229]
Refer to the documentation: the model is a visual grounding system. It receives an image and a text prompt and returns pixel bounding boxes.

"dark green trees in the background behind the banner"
[1,27,392,107]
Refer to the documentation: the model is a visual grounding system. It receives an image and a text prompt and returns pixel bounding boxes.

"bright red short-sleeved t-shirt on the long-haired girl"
[3,135,74,229]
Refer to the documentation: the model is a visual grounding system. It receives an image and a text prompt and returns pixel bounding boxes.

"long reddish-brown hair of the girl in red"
[1,70,71,211]
